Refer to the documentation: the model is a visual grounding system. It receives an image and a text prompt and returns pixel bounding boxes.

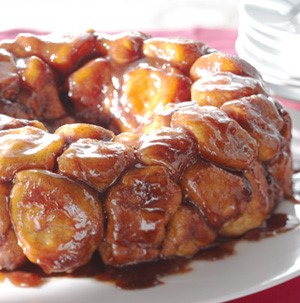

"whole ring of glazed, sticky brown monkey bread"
[0,31,292,273]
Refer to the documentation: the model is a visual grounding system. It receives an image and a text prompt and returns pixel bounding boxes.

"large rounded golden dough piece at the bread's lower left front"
[9,170,103,273]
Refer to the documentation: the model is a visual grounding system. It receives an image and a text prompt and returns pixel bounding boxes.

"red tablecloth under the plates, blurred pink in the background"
[0,28,300,303]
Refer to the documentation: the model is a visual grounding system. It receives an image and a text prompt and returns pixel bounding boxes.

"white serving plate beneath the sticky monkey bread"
[0,111,300,303]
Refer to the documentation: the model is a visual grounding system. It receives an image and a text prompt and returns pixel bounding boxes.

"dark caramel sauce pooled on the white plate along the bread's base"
[0,210,300,290]
